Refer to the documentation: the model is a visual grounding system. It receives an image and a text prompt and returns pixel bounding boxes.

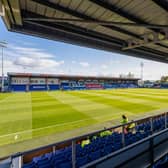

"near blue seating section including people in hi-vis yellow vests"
[17,114,168,168]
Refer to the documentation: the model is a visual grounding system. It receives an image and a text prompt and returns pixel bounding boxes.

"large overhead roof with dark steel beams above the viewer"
[0,0,168,63]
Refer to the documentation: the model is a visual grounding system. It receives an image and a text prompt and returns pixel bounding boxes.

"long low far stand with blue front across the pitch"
[8,72,139,91]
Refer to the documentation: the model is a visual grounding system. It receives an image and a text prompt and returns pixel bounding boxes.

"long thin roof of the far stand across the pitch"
[8,72,139,81]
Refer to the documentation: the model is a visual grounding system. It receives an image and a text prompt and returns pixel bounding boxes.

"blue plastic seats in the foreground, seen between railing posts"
[23,117,168,168]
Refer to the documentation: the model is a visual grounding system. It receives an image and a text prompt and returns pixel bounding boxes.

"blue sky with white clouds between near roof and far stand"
[0,18,168,80]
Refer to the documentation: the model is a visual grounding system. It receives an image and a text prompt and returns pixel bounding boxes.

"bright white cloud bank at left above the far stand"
[0,44,65,74]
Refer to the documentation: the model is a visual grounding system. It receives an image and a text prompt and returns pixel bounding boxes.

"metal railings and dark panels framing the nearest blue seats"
[0,112,168,168]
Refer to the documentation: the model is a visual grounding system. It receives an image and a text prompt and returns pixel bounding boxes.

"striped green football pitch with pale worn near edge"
[0,89,168,157]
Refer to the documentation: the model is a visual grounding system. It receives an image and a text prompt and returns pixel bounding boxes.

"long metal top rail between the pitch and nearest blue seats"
[8,112,168,158]
